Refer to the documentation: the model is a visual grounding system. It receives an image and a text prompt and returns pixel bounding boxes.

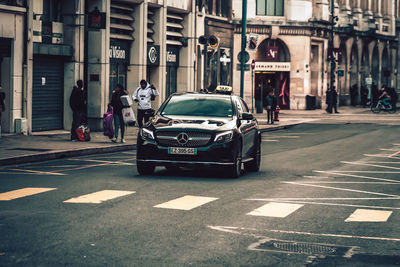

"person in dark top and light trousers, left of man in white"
[111,84,128,143]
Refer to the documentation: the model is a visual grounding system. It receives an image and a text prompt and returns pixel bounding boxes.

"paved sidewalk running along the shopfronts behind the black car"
[0,107,378,166]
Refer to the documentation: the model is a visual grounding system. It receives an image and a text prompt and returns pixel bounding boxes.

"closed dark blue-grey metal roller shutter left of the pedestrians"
[32,57,64,131]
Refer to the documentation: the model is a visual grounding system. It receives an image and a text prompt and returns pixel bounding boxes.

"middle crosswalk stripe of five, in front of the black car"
[154,195,218,210]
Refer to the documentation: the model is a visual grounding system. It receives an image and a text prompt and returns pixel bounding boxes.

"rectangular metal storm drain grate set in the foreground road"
[257,240,350,256]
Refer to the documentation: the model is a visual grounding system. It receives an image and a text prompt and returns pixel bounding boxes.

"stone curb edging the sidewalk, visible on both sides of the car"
[0,123,300,166]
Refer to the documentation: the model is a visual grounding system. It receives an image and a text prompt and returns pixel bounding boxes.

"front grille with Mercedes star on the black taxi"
[156,131,212,147]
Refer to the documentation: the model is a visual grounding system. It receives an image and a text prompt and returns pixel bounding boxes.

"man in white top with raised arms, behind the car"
[132,80,158,128]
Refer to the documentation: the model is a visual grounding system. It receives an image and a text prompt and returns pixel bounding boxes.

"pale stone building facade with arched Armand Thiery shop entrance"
[233,0,400,112]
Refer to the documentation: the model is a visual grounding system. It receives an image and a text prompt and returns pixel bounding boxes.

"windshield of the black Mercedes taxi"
[161,95,233,118]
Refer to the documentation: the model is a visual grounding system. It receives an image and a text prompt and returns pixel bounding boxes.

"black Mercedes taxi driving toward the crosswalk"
[137,93,261,178]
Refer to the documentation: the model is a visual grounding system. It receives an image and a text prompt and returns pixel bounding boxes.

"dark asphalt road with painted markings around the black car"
[0,123,400,266]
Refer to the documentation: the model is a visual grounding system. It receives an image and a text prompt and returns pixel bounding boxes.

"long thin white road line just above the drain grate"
[208,225,400,242]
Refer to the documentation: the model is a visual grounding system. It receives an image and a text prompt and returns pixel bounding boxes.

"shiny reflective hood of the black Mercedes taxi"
[151,115,235,131]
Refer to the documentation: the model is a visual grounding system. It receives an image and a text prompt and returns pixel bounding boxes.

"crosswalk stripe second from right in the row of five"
[247,202,304,218]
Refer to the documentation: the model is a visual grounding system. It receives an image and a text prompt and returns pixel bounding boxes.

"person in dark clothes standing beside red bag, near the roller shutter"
[69,80,86,141]
